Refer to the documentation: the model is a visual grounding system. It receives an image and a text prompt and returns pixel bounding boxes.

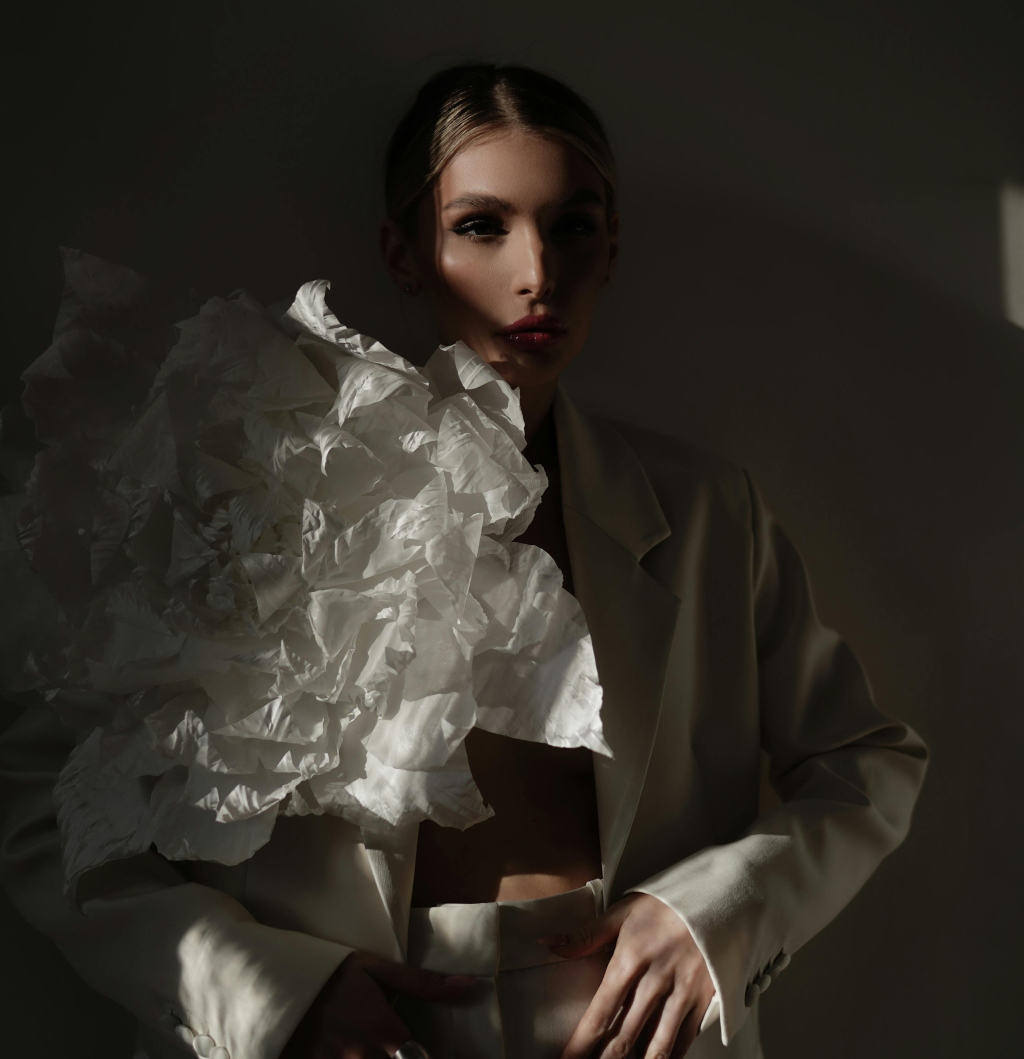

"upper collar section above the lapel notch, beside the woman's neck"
[554,387,671,561]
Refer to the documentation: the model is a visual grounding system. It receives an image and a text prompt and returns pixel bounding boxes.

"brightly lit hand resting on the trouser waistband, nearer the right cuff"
[544,894,715,1059]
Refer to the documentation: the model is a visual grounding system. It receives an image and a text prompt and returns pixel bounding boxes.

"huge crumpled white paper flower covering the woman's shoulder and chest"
[24,264,610,887]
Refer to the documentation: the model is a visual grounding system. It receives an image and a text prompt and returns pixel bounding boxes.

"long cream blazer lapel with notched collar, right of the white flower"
[555,390,679,902]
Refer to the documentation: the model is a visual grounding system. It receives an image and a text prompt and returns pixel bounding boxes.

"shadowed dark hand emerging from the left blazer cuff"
[281,953,473,1059]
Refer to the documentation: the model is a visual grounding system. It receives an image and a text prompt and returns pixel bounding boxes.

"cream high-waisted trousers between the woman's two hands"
[395,880,761,1059]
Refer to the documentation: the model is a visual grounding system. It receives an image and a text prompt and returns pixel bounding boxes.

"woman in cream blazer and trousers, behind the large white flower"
[3,66,927,1059]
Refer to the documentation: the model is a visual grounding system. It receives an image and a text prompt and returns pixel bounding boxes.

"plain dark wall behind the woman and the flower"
[0,0,1024,1059]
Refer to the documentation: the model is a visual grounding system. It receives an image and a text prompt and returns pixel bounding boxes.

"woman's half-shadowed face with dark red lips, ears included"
[382,130,618,396]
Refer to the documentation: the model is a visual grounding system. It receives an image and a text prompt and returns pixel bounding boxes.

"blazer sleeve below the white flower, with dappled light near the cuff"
[0,706,352,1059]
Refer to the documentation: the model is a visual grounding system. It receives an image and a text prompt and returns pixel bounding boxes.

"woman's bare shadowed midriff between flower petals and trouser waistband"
[412,729,601,908]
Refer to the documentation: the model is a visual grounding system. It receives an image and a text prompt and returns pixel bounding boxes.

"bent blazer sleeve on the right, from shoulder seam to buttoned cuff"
[633,479,928,1044]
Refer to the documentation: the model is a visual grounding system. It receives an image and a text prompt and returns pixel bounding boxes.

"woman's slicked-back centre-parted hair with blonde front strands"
[384,62,615,233]
